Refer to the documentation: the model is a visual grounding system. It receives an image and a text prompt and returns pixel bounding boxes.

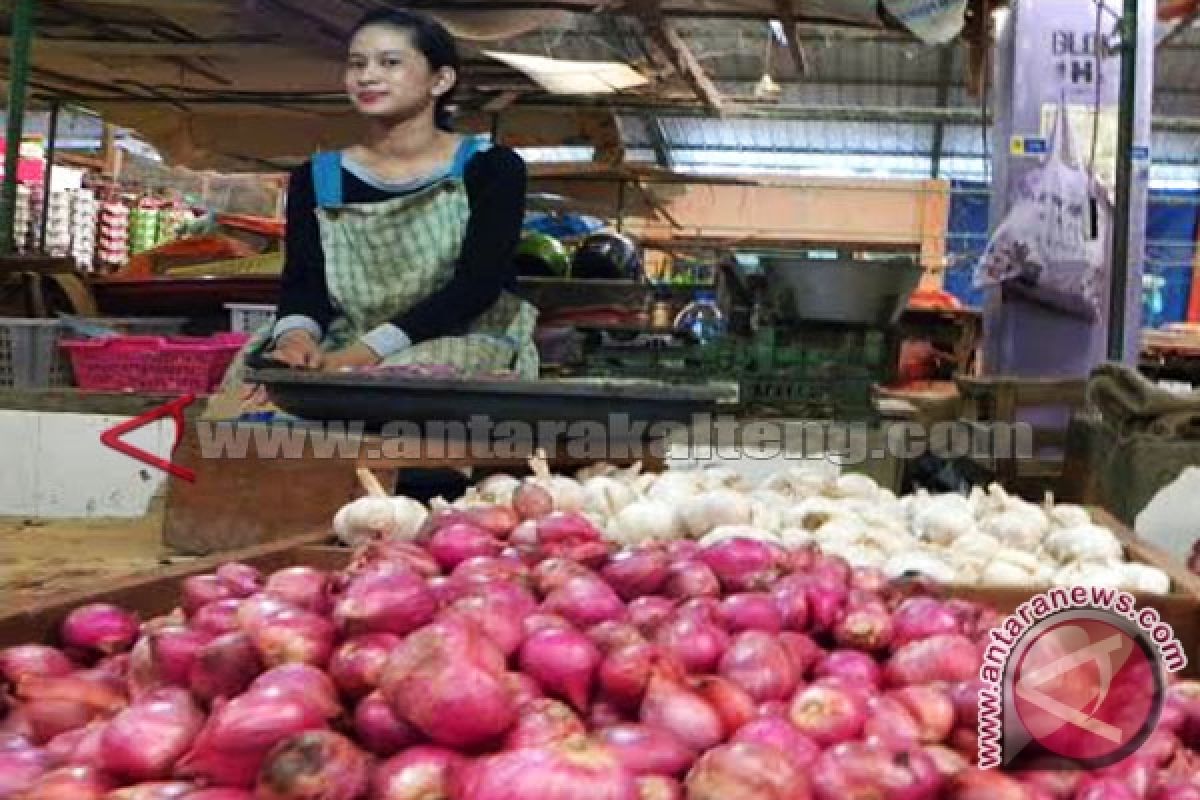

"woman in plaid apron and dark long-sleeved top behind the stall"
[241,11,538,379]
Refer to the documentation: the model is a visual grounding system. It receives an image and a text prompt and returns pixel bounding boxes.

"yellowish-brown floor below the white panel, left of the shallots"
[0,509,196,606]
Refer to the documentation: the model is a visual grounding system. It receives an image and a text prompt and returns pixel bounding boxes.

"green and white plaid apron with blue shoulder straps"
[227,137,539,393]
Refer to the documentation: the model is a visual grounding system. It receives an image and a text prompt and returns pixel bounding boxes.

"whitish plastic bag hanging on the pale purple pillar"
[974,104,1112,320]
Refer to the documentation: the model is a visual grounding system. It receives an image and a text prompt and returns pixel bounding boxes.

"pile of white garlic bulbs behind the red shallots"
[333,458,1171,594]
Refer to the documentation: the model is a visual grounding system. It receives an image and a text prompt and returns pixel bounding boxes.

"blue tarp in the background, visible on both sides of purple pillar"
[946,181,1200,326]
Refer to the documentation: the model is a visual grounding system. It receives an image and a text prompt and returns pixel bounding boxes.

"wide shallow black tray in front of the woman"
[246,368,728,428]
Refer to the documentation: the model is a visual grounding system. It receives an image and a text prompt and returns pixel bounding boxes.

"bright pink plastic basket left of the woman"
[61,333,250,395]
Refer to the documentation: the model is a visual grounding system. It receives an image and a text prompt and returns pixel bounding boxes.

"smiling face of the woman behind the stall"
[346,25,455,119]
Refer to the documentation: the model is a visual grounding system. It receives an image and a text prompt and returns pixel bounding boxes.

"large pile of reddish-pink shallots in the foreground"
[0,498,1200,800]
